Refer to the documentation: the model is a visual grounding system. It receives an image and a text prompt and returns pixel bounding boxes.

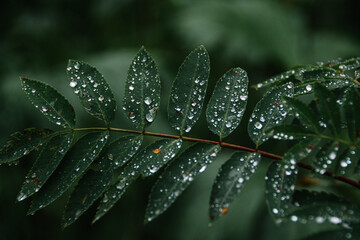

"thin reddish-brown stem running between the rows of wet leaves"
[73,127,360,189]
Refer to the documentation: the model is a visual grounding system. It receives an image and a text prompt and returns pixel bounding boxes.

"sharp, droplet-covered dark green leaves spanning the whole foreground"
[0,46,360,239]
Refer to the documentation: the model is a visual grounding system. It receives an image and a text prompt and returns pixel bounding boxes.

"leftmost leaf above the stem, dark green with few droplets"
[20,77,75,128]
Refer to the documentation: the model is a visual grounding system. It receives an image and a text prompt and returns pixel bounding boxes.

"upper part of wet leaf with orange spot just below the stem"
[124,139,182,176]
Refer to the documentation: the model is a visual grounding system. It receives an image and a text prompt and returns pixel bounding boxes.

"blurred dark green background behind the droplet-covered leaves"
[0,0,360,240]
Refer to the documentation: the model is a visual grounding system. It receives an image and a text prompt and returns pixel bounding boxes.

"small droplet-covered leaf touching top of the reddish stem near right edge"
[313,141,339,174]
